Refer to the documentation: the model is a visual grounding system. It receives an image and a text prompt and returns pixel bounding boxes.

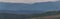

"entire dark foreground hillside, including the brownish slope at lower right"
[0,11,60,19]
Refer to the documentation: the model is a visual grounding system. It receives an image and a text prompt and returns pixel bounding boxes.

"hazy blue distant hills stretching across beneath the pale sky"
[0,1,60,14]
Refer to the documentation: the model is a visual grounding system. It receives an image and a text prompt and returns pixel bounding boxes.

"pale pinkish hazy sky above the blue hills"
[0,0,57,3]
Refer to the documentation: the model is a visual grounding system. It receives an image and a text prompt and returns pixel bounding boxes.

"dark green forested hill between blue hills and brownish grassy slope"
[0,11,60,19]
